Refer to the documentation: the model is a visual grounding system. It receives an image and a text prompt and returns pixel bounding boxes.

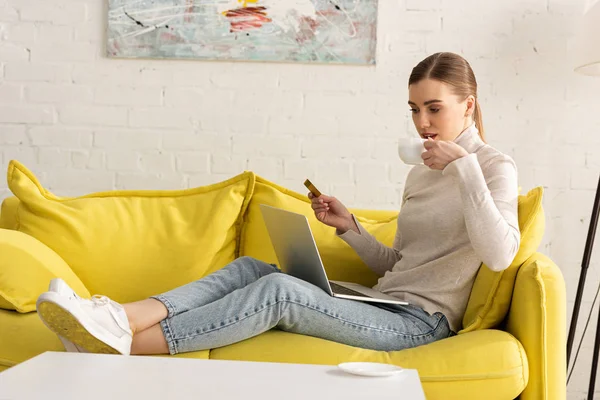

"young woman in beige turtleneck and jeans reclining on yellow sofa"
[37,53,520,354]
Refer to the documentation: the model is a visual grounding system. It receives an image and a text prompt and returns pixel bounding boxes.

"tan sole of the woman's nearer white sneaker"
[37,293,123,354]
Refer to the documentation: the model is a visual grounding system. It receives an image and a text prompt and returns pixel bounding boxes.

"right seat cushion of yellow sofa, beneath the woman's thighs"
[210,330,529,400]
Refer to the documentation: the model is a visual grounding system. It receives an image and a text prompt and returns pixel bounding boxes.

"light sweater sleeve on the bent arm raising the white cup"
[443,153,521,271]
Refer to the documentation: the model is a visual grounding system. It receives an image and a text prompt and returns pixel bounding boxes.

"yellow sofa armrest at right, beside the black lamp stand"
[506,253,567,400]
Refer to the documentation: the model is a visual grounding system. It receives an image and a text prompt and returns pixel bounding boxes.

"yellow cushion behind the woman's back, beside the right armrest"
[459,187,545,333]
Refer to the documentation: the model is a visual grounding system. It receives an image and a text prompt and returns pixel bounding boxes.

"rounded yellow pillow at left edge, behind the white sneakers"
[0,229,90,313]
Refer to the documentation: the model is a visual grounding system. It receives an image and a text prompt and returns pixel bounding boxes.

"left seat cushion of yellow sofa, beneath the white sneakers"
[0,310,210,372]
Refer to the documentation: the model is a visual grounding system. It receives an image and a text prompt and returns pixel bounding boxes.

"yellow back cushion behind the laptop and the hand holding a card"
[240,176,398,286]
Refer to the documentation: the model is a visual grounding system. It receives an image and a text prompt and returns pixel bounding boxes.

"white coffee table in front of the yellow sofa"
[0,352,425,400]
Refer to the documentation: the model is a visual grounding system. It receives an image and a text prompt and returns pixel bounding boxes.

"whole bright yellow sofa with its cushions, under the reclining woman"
[0,161,566,400]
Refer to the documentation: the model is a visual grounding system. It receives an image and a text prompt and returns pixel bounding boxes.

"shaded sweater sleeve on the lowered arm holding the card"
[336,215,402,276]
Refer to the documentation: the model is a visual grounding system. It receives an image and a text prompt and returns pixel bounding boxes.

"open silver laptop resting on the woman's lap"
[260,204,408,305]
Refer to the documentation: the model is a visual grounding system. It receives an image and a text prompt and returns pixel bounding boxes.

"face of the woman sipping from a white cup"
[408,79,475,141]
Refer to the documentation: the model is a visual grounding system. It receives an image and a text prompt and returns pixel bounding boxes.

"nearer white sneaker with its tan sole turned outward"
[36,282,133,355]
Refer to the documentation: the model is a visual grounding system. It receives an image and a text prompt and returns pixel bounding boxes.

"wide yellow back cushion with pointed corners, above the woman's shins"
[8,161,254,302]
